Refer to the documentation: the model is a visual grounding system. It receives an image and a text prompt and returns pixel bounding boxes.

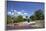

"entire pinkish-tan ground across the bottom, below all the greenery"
[6,20,44,30]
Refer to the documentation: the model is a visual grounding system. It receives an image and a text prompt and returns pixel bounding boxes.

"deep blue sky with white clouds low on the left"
[7,1,44,16]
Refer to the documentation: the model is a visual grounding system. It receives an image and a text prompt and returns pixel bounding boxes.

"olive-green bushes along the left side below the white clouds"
[7,15,24,24]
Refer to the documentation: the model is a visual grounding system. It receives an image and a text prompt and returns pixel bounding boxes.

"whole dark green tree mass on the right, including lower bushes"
[30,10,44,20]
